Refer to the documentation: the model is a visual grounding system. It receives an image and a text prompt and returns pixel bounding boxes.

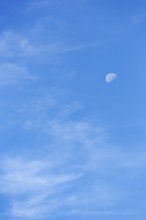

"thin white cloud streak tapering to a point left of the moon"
[0,27,109,61]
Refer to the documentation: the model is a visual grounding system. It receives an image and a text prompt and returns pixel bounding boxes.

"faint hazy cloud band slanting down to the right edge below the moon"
[17,90,146,172]
